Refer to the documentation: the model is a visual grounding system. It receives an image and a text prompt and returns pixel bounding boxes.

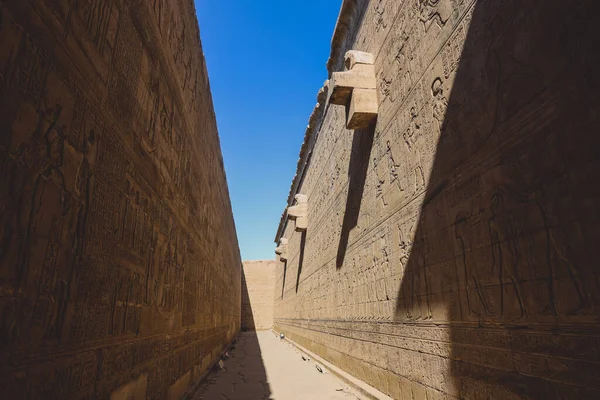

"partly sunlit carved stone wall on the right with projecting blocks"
[275,0,600,400]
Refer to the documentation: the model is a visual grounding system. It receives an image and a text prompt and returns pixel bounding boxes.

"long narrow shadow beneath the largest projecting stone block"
[338,125,375,268]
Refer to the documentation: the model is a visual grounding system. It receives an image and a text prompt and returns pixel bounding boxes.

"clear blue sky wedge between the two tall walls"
[196,0,342,260]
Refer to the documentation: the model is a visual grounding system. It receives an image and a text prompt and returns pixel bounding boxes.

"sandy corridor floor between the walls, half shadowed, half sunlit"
[193,331,358,400]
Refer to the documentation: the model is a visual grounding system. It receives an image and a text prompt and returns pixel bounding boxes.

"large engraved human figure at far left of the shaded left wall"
[0,104,72,338]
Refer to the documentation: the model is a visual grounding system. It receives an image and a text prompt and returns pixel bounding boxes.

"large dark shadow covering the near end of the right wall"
[396,0,600,399]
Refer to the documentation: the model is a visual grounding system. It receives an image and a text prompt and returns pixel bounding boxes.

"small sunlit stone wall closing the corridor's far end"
[241,260,275,331]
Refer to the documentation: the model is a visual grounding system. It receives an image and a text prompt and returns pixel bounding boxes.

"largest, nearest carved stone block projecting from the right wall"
[327,50,379,129]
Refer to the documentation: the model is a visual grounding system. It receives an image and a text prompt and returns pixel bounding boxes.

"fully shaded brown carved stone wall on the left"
[0,0,241,399]
